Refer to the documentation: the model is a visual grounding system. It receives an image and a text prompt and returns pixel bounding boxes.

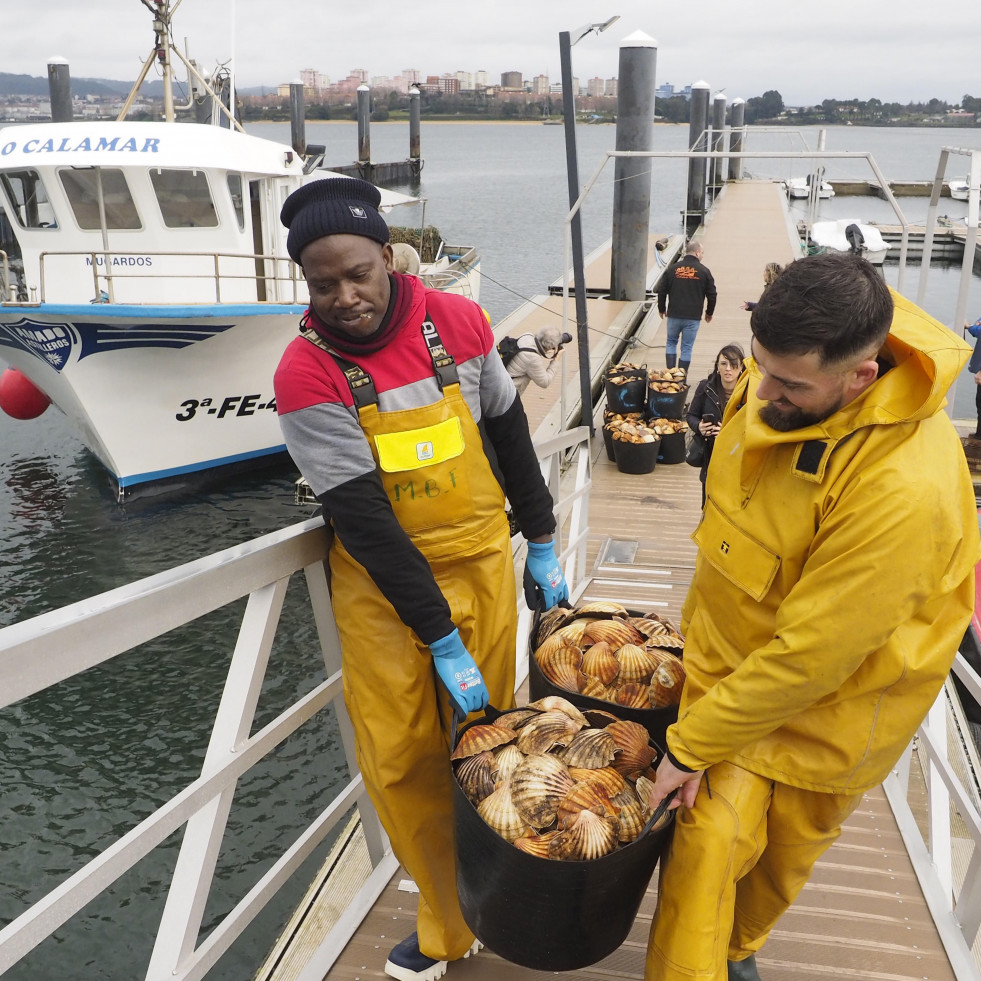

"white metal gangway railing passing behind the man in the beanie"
[0,428,590,981]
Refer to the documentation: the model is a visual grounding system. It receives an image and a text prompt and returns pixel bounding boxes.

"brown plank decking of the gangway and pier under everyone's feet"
[310,181,954,981]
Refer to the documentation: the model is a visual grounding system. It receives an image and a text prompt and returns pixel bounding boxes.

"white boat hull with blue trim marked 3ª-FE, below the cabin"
[0,304,305,498]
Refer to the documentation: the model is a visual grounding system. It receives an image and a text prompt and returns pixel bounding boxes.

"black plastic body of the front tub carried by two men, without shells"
[453,704,674,971]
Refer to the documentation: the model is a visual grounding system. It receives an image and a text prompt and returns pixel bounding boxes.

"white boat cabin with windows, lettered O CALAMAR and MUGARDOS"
[0,122,304,304]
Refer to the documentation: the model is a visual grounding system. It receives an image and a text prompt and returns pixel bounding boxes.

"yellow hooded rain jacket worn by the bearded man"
[667,294,981,793]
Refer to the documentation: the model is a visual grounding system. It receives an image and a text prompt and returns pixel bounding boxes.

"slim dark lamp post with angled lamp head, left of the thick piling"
[559,16,620,436]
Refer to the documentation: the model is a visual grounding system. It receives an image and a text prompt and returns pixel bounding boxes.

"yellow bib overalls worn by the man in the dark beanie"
[330,384,516,960]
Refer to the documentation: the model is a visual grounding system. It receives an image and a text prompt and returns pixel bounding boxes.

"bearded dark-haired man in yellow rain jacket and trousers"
[645,253,981,981]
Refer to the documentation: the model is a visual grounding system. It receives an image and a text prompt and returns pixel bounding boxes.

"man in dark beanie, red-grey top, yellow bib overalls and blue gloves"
[275,178,568,981]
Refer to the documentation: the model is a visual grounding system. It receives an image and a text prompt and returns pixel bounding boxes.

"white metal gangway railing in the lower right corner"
[882,654,981,981]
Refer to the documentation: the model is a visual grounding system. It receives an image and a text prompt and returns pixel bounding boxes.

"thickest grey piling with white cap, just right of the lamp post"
[610,31,657,300]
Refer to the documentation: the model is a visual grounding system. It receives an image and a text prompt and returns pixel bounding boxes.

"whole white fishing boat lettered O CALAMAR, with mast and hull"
[0,2,479,501]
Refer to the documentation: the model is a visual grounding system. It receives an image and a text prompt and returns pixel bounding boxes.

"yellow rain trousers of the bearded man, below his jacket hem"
[644,763,862,981]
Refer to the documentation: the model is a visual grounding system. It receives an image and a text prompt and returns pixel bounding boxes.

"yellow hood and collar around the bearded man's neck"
[726,290,971,462]
